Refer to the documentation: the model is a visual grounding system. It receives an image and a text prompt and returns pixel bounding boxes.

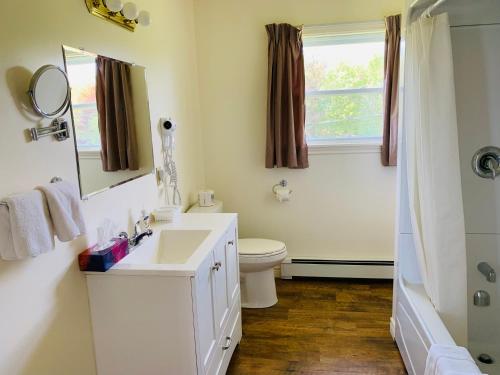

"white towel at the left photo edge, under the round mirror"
[0,191,54,260]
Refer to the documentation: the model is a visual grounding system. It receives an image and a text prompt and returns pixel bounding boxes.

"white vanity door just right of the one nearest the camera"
[212,238,230,334]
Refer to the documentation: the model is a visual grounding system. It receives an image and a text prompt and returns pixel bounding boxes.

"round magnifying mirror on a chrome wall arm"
[28,65,71,118]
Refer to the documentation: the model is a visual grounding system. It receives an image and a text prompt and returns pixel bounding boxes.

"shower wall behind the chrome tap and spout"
[451,23,500,358]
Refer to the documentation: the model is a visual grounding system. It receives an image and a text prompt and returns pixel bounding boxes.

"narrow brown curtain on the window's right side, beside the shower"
[382,14,401,166]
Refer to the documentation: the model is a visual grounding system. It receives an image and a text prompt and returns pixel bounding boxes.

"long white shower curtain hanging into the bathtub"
[404,14,467,344]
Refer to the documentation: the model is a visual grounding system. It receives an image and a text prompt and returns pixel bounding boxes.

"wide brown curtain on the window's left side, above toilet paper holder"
[266,24,309,168]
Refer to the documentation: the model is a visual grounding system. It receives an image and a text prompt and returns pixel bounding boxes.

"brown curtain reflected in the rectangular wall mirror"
[96,56,139,172]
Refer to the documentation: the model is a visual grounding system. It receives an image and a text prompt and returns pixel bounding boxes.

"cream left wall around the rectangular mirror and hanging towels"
[0,0,204,375]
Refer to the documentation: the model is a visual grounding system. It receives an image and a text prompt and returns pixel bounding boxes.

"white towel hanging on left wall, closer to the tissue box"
[37,181,86,242]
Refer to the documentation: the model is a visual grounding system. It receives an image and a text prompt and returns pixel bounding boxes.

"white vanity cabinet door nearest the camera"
[192,248,218,374]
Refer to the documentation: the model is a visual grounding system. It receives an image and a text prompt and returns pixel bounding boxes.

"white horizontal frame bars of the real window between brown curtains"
[302,21,385,154]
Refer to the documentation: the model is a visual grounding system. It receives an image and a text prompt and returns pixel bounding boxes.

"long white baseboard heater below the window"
[281,258,394,279]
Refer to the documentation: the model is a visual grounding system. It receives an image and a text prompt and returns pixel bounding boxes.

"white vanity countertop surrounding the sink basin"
[85,213,237,277]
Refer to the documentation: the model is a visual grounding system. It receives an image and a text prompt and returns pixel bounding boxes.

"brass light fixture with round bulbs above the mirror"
[85,0,151,31]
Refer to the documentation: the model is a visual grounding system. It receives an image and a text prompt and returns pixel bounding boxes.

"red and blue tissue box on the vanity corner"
[78,238,128,272]
